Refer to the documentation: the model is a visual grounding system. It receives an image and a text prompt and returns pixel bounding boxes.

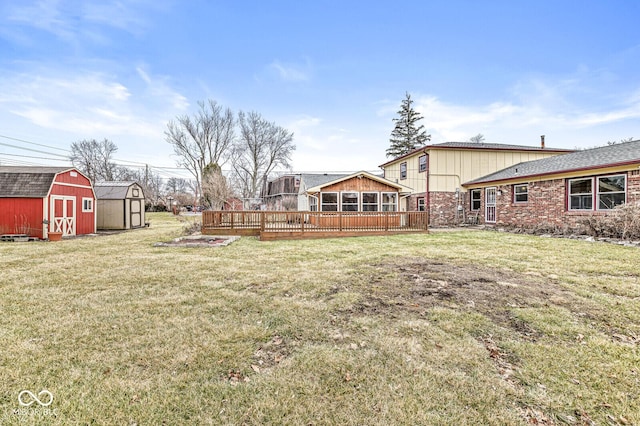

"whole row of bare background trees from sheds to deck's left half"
[70,100,295,209]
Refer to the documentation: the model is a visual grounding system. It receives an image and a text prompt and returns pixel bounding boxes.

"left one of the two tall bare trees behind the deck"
[165,99,235,198]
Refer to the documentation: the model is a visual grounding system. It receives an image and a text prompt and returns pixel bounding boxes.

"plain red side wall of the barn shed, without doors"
[0,198,43,238]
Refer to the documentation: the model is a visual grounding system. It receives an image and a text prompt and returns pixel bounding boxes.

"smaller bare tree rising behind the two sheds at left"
[69,139,120,182]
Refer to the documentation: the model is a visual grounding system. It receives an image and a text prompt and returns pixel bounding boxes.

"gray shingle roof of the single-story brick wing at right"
[465,140,640,184]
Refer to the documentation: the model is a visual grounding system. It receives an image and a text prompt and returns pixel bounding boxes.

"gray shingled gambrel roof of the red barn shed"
[0,166,70,198]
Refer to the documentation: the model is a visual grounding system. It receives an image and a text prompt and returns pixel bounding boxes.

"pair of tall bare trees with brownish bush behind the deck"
[165,100,295,209]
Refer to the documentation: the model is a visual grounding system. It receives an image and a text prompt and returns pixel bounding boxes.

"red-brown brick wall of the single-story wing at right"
[465,170,640,232]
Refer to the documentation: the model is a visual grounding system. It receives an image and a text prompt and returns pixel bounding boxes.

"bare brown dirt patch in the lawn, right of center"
[342,259,598,340]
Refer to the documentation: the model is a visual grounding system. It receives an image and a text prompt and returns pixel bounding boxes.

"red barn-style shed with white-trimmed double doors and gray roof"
[0,166,96,239]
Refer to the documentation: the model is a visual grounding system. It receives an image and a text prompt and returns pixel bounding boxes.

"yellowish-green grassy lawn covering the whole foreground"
[0,214,640,425]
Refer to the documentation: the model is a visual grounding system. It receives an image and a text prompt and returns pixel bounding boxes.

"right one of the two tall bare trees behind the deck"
[233,112,296,203]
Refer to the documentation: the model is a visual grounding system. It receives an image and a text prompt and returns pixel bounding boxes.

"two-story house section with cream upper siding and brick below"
[380,140,571,226]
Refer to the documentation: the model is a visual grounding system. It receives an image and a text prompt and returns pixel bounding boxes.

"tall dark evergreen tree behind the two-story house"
[387,92,431,158]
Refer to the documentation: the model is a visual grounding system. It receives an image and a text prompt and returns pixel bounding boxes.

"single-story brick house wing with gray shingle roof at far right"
[463,141,640,229]
